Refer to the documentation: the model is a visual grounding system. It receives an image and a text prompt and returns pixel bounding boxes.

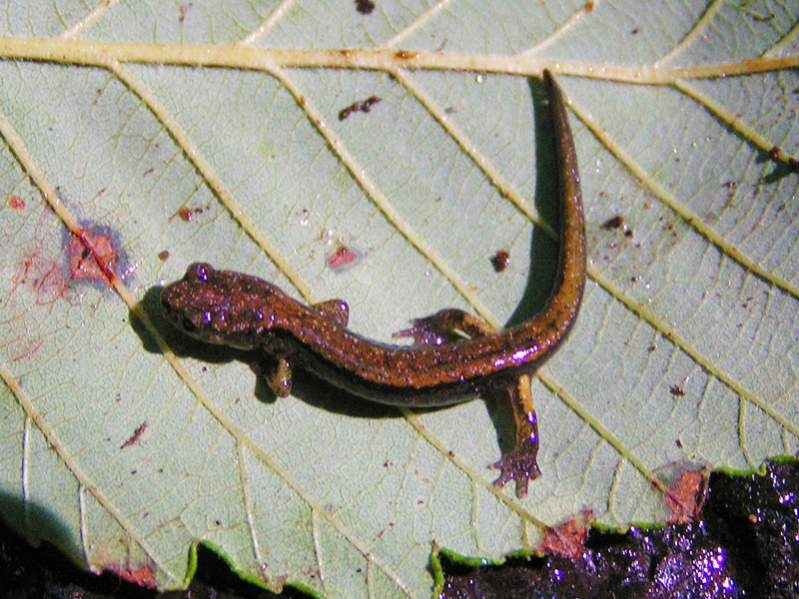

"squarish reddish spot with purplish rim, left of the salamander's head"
[67,226,119,285]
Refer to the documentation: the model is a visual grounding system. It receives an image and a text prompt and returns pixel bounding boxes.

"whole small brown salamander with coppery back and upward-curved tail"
[161,71,586,496]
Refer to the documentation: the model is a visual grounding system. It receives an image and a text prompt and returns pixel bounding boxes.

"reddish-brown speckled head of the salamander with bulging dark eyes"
[161,262,282,349]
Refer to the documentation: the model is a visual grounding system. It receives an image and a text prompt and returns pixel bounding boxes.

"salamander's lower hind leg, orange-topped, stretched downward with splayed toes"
[486,374,541,497]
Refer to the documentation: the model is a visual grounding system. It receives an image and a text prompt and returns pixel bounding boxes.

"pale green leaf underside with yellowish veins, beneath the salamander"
[0,0,799,597]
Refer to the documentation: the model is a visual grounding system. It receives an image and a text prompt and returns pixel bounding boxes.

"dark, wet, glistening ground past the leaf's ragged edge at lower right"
[441,463,799,599]
